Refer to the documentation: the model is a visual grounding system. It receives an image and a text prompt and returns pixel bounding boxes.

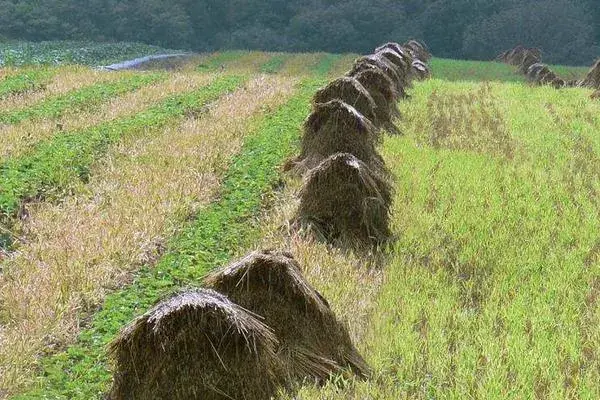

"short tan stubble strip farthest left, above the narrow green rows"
[0,66,123,112]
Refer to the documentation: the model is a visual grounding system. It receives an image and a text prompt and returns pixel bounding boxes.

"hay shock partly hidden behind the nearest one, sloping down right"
[205,251,369,383]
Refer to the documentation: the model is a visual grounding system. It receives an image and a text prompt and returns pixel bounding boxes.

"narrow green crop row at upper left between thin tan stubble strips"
[0,74,166,124]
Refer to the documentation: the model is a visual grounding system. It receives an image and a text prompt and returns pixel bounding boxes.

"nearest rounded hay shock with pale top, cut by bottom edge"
[109,290,285,400]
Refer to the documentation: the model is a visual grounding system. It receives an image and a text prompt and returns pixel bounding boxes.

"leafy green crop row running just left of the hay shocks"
[9,79,323,399]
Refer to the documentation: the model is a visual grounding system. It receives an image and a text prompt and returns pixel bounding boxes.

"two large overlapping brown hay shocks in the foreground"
[109,251,369,400]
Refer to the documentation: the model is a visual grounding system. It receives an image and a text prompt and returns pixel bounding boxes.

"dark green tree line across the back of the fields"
[0,0,600,65]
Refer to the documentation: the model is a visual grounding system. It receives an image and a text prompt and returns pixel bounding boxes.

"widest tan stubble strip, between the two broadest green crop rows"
[0,73,293,396]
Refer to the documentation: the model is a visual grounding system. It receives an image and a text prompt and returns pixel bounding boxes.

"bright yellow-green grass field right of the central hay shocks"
[294,80,600,400]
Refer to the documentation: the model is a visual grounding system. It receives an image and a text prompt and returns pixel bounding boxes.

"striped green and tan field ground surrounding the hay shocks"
[0,48,600,400]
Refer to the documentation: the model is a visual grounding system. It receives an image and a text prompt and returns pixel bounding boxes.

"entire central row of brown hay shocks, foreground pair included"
[109,41,430,400]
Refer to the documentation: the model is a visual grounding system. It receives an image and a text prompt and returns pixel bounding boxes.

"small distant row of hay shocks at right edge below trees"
[496,45,600,93]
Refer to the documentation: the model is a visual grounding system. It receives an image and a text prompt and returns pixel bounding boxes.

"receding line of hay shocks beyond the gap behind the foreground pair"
[288,40,431,251]
